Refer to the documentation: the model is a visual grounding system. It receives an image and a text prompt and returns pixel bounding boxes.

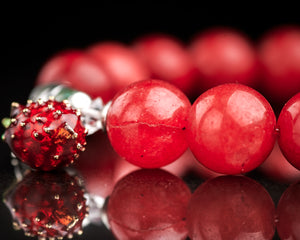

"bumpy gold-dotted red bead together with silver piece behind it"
[2,85,108,171]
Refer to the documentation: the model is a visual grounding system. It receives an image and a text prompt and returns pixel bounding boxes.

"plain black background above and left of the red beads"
[0,4,300,239]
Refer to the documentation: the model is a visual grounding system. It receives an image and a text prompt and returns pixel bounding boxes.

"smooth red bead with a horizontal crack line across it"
[107,80,190,168]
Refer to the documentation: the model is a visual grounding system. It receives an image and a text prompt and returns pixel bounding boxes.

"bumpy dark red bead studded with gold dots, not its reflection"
[4,100,86,171]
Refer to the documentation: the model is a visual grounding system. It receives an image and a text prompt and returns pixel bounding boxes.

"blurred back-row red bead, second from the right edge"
[191,29,258,89]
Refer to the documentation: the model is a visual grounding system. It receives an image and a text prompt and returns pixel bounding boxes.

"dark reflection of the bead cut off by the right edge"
[276,182,300,240]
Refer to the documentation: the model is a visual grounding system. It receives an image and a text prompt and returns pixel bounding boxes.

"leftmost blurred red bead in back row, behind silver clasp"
[37,50,114,102]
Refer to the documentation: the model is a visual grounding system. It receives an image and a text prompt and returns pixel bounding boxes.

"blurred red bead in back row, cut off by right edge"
[259,26,300,106]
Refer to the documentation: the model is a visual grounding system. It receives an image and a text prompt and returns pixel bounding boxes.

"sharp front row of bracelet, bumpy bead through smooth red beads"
[4,80,300,174]
